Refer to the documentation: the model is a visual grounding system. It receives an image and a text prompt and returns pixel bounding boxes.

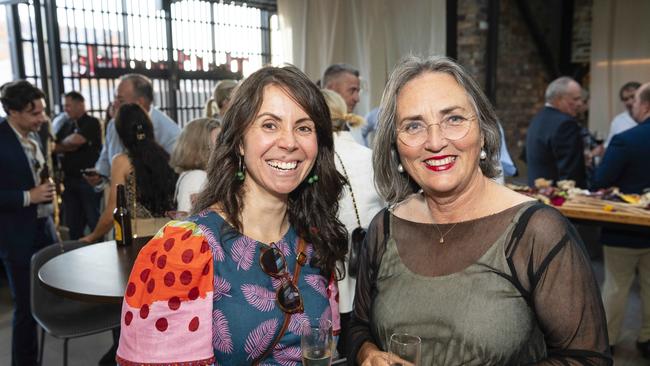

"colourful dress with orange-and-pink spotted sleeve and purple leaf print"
[117,210,337,365]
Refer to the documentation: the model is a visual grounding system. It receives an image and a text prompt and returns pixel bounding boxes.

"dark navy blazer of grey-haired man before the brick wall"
[526,106,587,188]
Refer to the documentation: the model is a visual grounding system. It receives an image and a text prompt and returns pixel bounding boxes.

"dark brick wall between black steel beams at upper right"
[457,0,593,180]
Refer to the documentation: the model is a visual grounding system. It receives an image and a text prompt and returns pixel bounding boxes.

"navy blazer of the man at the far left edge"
[0,119,40,264]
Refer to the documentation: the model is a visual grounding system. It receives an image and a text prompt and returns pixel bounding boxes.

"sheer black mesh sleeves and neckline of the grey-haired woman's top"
[347,204,612,365]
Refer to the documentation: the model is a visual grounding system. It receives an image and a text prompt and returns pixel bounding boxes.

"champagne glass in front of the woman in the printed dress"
[300,318,334,366]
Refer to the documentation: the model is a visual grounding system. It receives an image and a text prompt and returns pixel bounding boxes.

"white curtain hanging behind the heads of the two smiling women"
[278,0,446,115]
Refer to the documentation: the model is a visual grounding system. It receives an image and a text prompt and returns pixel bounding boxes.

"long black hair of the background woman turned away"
[115,103,178,217]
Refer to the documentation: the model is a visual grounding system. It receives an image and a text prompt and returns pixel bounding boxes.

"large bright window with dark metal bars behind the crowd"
[7,0,278,126]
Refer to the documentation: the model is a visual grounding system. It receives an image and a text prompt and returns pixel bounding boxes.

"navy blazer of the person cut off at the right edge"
[592,118,650,248]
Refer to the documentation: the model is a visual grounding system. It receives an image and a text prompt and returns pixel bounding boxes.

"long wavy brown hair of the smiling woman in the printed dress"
[194,66,348,276]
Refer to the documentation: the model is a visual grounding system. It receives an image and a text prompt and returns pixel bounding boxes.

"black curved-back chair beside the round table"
[30,241,122,366]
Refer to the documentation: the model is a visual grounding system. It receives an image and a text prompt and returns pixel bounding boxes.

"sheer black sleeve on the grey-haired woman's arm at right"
[506,204,612,365]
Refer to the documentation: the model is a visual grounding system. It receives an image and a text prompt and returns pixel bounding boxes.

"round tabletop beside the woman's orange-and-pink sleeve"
[38,237,150,303]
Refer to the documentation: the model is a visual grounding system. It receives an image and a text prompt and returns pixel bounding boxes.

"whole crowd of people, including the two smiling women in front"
[0,56,650,366]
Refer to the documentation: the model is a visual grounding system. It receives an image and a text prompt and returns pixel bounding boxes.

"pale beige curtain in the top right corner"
[589,0,650,136]
